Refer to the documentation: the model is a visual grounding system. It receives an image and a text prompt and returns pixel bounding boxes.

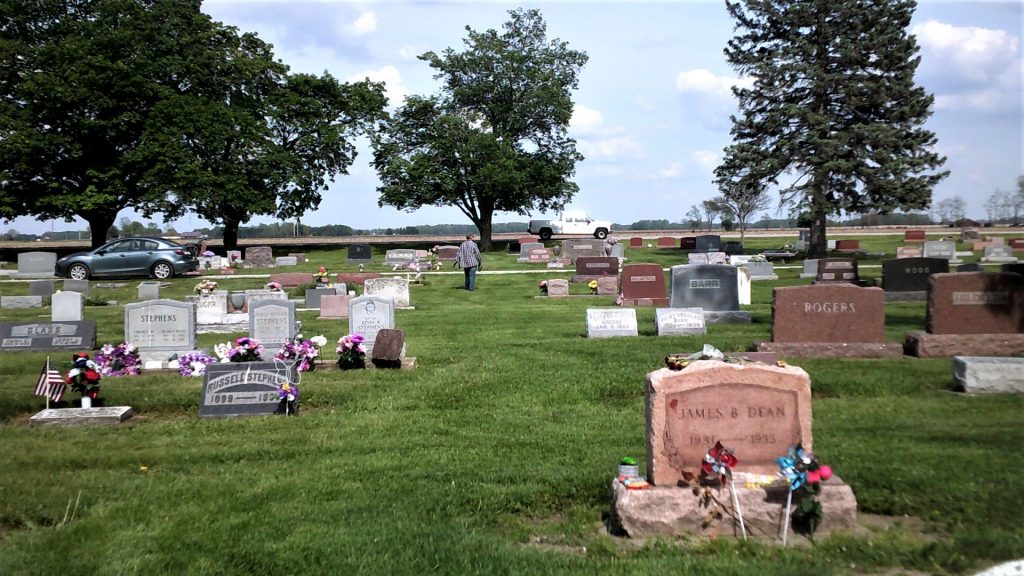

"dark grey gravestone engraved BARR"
[669,264,751,324]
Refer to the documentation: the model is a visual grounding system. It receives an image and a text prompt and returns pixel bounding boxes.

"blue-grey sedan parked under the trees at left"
[54,238,199,280]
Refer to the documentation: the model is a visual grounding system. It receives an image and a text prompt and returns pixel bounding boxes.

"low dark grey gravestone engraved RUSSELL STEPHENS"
[199,362,299,418]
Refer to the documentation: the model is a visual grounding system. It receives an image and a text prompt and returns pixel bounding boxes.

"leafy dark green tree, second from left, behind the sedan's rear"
[152,27,387,248]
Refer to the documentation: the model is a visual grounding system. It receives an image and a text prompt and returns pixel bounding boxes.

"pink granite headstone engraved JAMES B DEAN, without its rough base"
[645,360,814,479]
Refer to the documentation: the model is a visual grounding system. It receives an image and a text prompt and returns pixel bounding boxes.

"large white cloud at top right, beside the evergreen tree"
[910,19,1020,82]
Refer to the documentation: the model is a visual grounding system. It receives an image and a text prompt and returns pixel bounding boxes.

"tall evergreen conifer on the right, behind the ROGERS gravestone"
[716,0,948,257]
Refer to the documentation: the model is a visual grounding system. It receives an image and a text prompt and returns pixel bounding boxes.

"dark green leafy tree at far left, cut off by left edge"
[0,0,213,245]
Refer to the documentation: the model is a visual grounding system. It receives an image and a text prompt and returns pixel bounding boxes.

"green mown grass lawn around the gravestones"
[0,237,1024,575]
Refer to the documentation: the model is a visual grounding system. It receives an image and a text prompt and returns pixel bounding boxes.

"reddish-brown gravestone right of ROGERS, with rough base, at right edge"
[903,272,1024,358]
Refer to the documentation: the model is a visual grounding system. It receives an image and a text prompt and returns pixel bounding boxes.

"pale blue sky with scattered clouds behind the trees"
[5,0,1024,232]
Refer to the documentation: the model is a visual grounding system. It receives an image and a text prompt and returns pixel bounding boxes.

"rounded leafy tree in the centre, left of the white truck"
[373,9,587,250]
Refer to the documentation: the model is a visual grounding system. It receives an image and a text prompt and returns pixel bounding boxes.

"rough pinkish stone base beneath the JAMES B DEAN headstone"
[611,475,858,541]
